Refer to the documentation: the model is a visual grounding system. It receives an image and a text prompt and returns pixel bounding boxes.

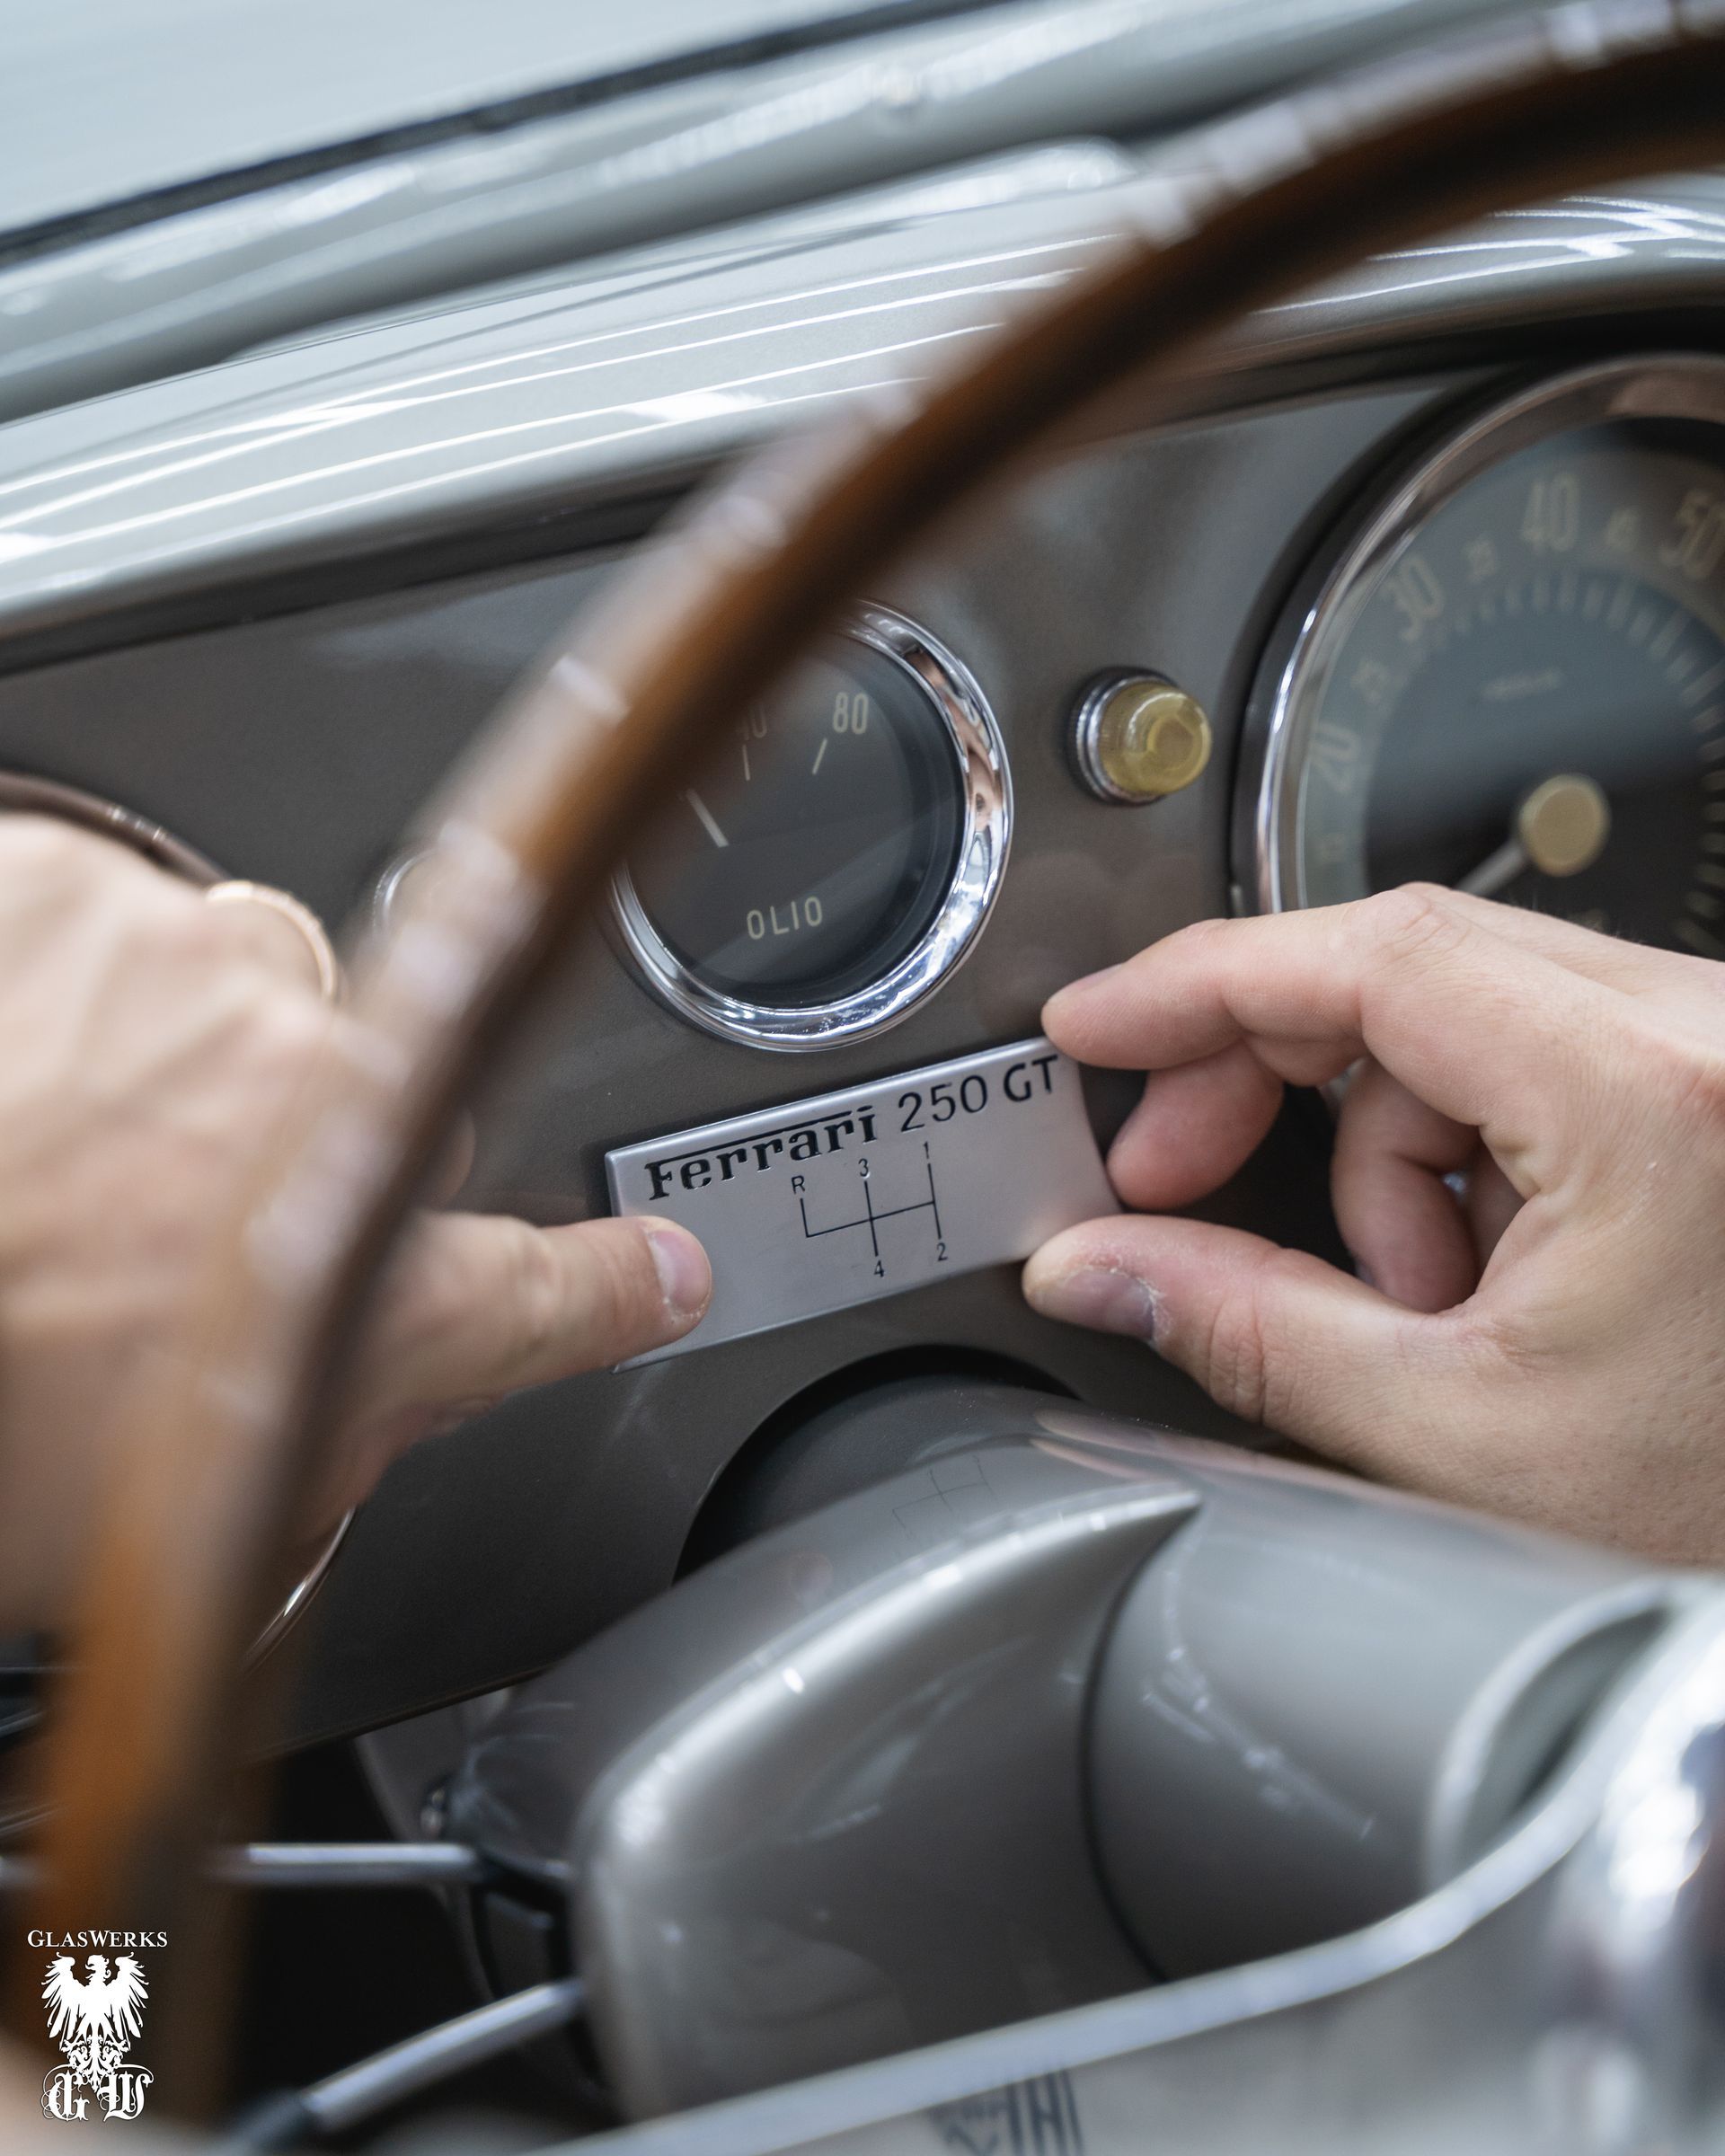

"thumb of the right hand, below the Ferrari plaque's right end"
[1024,1216,1468,1479]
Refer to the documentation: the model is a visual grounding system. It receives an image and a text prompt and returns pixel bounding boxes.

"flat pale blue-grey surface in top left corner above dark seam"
[0,0,995,231]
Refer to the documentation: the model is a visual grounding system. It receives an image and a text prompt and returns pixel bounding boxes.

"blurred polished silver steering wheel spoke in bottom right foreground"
[545,1591,1725,2156]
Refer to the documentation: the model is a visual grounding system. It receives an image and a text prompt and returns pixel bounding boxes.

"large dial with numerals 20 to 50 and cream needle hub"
[1244,358,1725,958]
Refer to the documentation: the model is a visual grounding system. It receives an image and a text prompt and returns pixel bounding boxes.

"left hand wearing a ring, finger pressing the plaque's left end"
[0,817,712,1626]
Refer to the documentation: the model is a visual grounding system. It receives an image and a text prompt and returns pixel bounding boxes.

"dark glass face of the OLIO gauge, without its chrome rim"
[630,638,964,1009]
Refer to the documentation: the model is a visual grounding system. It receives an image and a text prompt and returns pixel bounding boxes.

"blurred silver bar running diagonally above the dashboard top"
[0,0,1552,416]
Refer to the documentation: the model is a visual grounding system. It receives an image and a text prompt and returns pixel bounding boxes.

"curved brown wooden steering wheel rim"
[13,0,1725,2115]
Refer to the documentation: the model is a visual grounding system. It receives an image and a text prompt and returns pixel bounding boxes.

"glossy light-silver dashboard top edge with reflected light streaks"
[0,174,1725,667]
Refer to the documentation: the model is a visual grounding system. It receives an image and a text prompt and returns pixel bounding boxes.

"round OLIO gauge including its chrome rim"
[615,608,1012,1047]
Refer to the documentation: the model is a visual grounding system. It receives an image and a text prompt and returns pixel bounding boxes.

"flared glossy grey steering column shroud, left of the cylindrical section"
[578,1460,1186,2115]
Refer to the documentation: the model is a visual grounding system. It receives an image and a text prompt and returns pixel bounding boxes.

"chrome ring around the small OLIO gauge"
[610,605,1012,1055]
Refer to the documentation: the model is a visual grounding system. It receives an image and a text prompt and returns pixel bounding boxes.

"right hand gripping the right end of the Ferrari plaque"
[1024,886,1725,1563]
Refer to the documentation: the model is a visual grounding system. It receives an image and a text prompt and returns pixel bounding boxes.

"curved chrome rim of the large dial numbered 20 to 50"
[1235,351,1725,915]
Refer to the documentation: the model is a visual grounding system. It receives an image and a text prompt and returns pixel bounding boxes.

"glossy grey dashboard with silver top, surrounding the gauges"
[0,145,1725,1736]
